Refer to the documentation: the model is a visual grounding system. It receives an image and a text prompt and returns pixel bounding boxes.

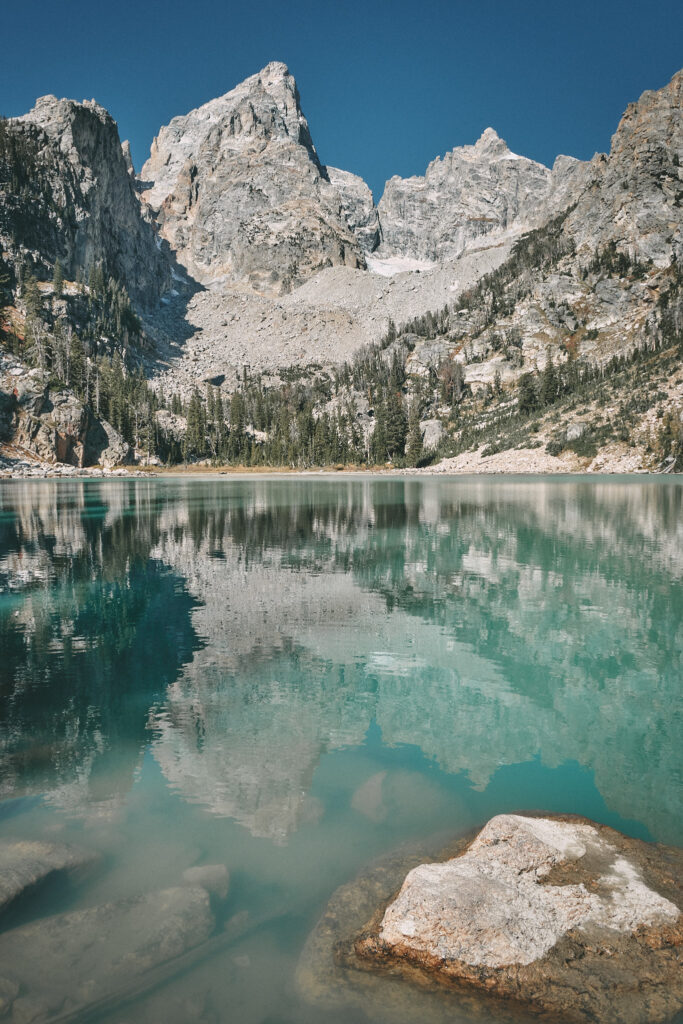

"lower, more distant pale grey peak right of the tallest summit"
[378,128,551,260]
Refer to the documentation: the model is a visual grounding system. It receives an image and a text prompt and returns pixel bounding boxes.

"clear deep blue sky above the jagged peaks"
[0,0,683,199]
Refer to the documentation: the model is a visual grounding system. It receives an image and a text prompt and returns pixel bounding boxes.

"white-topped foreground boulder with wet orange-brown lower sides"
[354,814,683,1022]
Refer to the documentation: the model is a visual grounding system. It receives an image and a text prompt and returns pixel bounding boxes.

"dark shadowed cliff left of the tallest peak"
[5,96,170,307]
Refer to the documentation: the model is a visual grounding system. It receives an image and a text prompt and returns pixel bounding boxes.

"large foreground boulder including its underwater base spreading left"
[297,815,683,1024]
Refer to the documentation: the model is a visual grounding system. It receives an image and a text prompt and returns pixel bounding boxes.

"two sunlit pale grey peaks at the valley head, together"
[136,63,551,278]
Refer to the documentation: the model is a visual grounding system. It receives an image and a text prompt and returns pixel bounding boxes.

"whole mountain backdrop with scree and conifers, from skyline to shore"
[0,62,683,472]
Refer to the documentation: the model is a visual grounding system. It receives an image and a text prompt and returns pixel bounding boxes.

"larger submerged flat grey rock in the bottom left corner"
[0,886,214,1022]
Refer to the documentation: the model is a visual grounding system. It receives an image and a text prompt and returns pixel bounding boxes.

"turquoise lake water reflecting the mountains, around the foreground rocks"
[0,475,683,1024]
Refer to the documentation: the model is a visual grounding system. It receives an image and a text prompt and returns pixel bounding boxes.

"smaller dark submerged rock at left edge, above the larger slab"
[0,840,99,913]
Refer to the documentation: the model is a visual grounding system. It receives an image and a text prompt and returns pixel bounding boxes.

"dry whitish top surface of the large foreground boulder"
[379,814,680,968]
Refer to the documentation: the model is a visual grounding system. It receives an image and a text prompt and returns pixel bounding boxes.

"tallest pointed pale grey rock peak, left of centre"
[141,62,365,294]
